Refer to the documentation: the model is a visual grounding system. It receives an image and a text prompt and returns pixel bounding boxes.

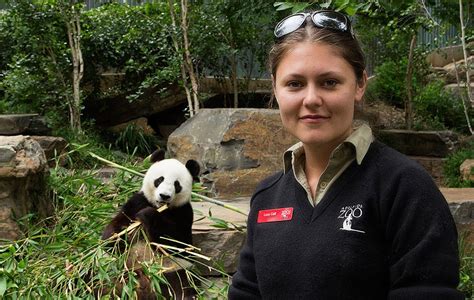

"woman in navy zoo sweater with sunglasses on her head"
[229,11,463,299]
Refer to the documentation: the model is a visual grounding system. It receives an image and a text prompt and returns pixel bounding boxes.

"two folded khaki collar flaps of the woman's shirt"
[283,124,374,173]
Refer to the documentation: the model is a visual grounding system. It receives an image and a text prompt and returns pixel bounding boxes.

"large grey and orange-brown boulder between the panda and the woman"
[168,109,297,197]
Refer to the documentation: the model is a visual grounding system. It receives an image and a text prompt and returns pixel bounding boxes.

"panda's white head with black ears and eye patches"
[141,150,200,207]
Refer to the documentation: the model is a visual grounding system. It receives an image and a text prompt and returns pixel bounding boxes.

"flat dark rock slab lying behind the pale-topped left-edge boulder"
[0,114,51,135]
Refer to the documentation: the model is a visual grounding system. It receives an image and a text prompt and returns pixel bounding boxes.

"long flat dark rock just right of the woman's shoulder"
[377,129,458,157]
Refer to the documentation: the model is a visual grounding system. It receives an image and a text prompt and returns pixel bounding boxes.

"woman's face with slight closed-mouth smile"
[273,42,366,147]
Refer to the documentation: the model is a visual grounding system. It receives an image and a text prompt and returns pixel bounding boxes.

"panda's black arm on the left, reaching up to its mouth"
[102,192,151,240]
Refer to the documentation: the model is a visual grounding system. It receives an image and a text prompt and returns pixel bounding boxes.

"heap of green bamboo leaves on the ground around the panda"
[0,144,229,299]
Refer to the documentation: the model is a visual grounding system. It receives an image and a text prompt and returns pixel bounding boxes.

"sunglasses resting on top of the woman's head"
[273,10,354,38]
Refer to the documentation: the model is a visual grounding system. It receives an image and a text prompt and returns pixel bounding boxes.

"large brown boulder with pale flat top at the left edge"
[0,136,53,240]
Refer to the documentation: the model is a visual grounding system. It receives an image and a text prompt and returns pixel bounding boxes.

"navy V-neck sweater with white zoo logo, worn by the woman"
[229,142,463,300]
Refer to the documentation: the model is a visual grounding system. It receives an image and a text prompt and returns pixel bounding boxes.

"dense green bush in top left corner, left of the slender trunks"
[0,0,82,130]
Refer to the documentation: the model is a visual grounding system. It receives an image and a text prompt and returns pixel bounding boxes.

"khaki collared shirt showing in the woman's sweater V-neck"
[283,124,374,206]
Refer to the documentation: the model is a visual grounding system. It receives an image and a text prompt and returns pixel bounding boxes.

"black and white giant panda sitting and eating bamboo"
[102,150,200,299]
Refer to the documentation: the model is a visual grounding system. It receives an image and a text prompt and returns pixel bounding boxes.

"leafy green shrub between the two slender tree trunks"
[83,1,179,101]
